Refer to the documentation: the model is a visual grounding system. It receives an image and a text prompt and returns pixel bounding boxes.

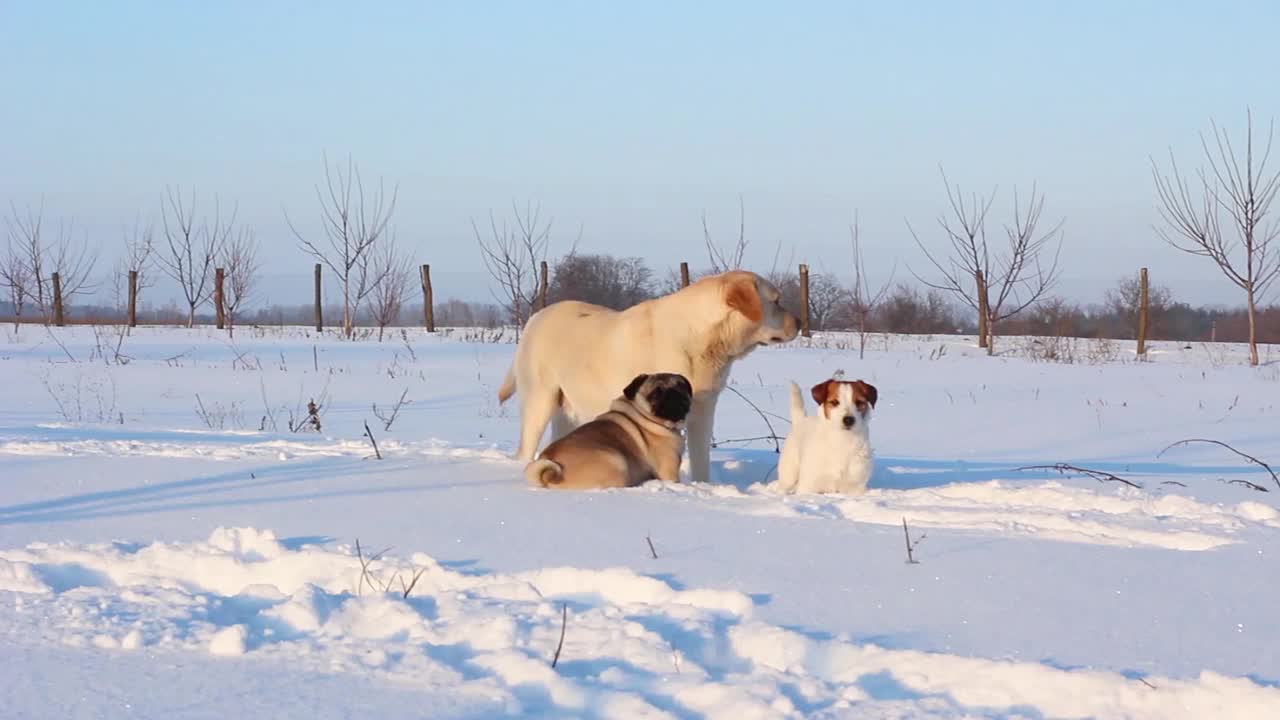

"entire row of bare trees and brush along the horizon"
[0,114,1280,356]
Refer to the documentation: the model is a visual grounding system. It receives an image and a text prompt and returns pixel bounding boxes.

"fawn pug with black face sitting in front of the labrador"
[525,373,694,489]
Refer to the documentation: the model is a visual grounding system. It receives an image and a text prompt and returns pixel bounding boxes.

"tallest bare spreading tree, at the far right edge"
[1151,110,1280,365]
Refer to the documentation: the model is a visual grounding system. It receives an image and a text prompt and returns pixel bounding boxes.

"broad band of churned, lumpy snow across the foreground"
[0,520,1280,720]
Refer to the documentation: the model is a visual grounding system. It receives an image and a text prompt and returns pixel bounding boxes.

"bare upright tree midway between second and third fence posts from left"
[156,187,236,328]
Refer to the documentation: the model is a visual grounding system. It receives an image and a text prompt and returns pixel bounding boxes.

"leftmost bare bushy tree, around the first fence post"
[5,201,97,322]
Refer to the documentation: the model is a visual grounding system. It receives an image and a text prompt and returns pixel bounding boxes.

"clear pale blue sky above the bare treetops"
[0,0,1280,302]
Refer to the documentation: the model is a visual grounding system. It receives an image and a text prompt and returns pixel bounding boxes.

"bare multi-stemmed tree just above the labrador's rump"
[471,197,550,336]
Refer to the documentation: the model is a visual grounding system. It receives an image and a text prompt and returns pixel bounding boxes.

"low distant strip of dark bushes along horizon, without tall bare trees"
[0,252,1280,343]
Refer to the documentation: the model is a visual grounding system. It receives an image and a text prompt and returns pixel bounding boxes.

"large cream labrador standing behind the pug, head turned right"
[498,270,799,482]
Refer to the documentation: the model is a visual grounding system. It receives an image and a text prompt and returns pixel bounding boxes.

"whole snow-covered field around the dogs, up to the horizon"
[0,327,1280,720]
